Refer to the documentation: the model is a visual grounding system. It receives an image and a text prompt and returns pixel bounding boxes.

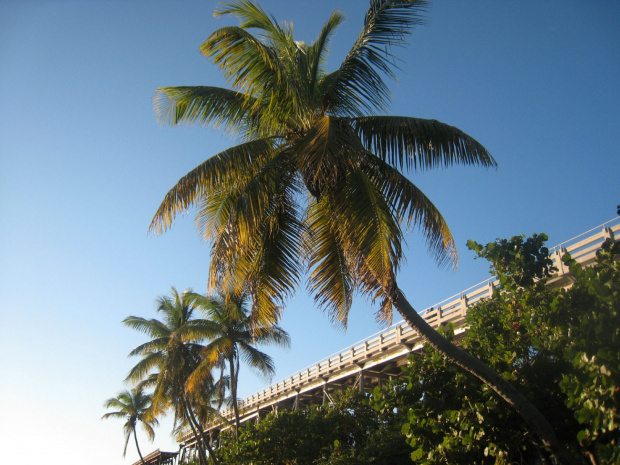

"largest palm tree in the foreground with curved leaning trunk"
[150,0,572,462]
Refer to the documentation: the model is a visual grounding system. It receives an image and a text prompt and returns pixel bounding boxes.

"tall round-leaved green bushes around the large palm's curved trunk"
[373,235,620,464]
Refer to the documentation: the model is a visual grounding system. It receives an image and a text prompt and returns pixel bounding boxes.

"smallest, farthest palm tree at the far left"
[101,388,158,465]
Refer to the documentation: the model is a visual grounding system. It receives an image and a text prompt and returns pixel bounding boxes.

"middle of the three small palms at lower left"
[123,287,218,464]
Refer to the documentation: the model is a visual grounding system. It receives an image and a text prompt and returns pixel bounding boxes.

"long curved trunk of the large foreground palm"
[384,286,582,465]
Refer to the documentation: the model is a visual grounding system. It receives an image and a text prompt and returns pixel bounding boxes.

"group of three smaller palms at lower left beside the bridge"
[104,287,290,465]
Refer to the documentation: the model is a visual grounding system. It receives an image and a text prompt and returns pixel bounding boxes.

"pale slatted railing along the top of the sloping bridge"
[217,218,620,417]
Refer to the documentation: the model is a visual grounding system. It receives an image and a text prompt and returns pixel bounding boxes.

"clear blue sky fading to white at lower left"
[0,0,620,465]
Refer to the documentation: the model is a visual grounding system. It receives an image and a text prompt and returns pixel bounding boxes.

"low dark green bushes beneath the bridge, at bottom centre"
[220,391,409,465]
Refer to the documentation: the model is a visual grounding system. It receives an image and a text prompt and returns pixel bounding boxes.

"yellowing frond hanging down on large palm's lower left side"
[198,153,303,314]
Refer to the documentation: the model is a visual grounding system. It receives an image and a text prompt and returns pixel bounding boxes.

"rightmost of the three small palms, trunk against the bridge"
[190,294,290,435]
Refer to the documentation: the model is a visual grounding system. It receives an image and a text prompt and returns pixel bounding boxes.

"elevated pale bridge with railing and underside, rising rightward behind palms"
[176,218,620,456]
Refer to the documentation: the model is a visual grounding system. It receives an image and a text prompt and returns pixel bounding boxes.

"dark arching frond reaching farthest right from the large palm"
[351,116,497,170]
